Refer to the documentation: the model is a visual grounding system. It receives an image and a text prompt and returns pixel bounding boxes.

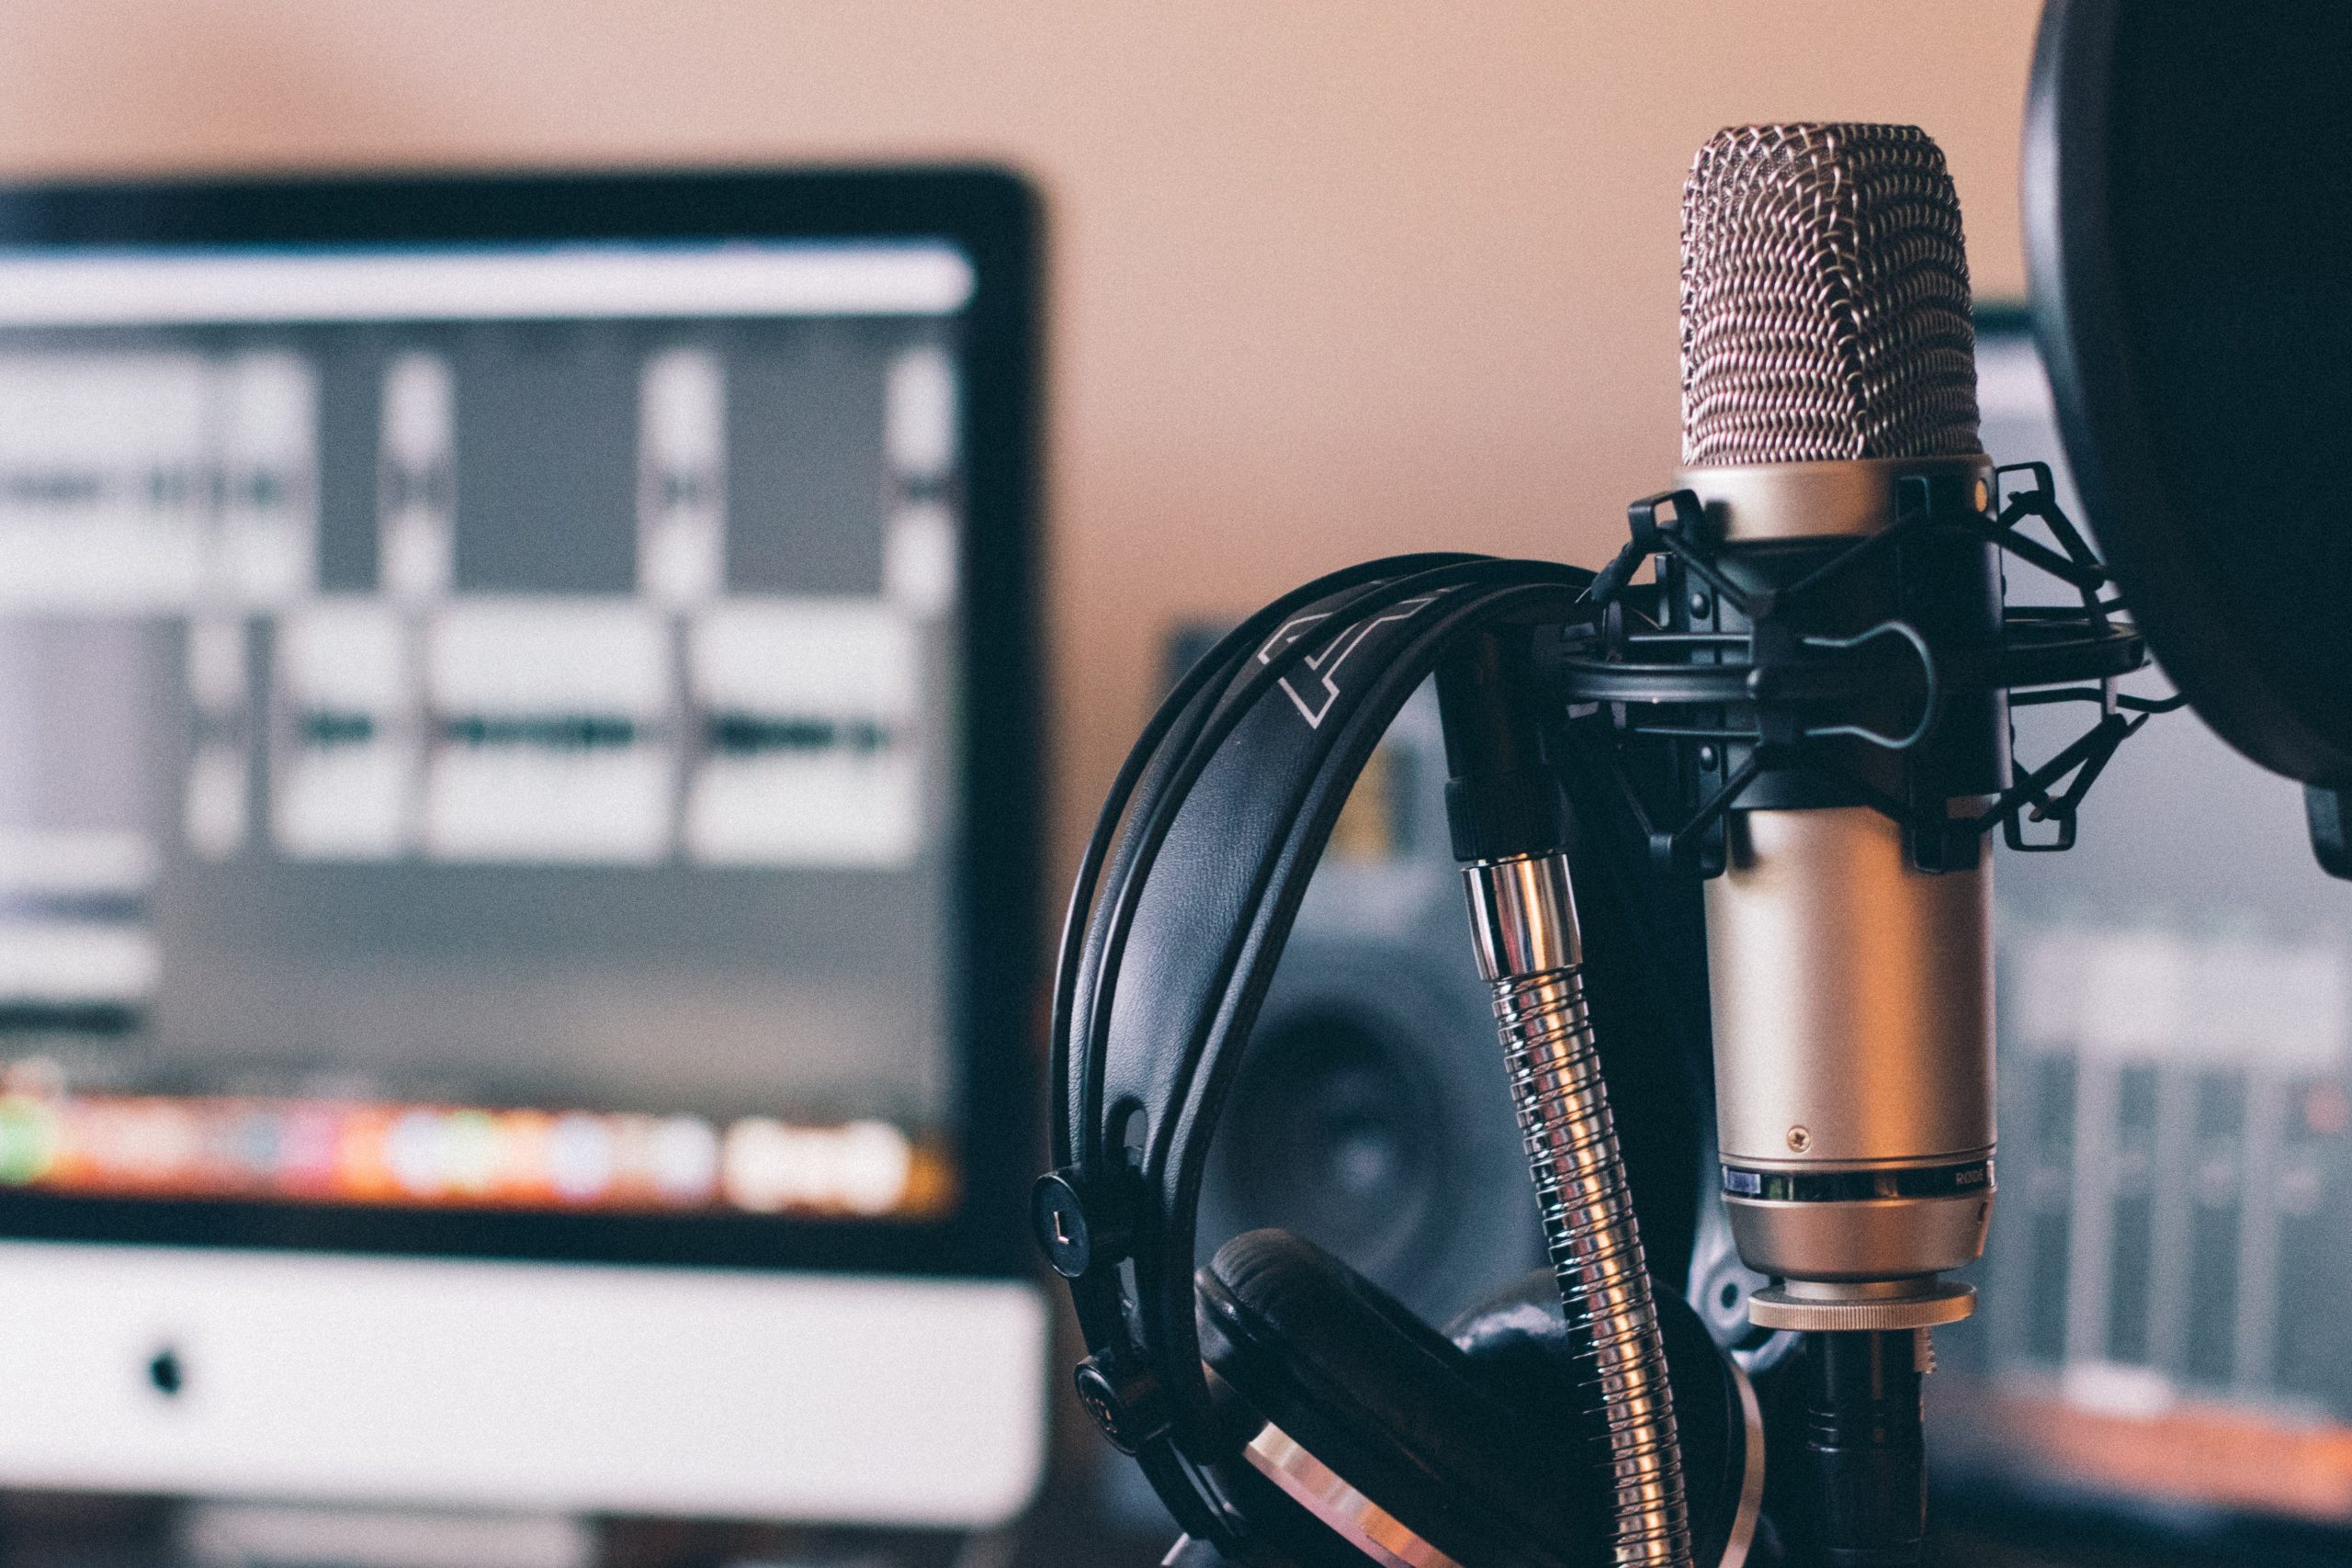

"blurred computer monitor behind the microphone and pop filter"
[1928,312,2352,1526]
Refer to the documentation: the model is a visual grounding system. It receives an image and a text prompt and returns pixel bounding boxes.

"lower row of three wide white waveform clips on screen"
[270,594,922,865]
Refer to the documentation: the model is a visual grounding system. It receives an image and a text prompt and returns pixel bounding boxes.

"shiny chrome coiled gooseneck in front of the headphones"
[1463,853,1691,1568]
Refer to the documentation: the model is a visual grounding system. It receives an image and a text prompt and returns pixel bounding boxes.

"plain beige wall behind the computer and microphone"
[0,0,2040,869]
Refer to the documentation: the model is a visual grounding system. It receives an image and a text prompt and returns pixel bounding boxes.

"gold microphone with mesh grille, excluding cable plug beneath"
[1677,125,2004,1331]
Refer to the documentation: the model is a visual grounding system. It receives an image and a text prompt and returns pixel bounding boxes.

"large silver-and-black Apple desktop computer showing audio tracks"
[0,169,1046,1526]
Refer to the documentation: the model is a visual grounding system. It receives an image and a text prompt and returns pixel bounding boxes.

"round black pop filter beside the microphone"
[2025,0,2352,877]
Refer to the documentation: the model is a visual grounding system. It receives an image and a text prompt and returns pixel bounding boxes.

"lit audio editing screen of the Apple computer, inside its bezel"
[0,244,971,1215]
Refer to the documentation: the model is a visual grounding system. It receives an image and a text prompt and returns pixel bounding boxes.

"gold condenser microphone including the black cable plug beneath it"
[1677,125,2008,1565]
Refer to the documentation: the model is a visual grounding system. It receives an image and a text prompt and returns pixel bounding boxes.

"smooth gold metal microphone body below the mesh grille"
[1677,456,1995,1331]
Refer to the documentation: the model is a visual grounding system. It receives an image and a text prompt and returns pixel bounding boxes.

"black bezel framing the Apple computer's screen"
[0,164,1042,1277]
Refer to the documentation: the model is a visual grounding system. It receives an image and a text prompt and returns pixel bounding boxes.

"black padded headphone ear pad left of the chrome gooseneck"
[1197,1229,1609,1568]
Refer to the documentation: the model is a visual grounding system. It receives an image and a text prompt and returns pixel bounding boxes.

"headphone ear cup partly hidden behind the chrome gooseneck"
[1446,1269,1778,1568]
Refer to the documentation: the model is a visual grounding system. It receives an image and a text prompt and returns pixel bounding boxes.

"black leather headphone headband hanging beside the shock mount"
[1035,555,1590,1542]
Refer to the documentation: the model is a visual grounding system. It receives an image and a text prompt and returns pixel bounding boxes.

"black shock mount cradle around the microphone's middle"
[1541,463,2183,877]
